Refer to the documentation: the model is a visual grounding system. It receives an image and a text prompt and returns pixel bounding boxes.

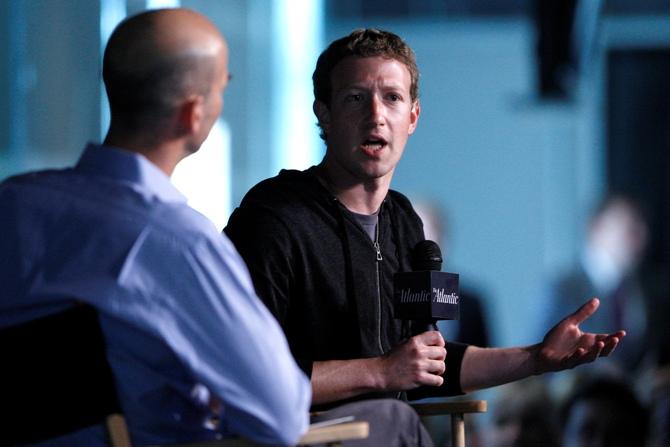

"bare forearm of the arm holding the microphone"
[312,357,386,405]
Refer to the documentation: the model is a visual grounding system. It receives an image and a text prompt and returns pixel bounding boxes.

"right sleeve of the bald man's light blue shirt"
[119,224,311,444]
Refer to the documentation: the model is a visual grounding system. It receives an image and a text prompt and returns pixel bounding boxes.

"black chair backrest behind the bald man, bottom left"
[0,304,120,445]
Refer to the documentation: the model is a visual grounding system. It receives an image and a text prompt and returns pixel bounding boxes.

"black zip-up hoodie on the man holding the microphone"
[224,167,465,408]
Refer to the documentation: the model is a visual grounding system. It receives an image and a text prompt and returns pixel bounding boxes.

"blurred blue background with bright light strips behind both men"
[0,0,670,444]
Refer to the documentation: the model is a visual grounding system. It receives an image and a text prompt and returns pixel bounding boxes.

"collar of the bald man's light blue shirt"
[75,143,186,202]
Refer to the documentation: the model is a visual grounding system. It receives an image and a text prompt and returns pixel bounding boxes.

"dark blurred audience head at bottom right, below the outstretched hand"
[560,377,649,447]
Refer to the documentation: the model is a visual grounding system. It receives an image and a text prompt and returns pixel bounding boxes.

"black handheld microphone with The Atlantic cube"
[393,240,460,335]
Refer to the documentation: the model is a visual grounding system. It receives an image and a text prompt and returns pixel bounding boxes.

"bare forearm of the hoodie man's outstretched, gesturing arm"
[461,345,539,392]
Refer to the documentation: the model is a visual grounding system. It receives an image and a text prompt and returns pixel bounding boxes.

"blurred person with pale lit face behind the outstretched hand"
[547,196,650,371]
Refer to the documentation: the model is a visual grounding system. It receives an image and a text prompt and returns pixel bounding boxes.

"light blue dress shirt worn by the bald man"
[0,145,311,446]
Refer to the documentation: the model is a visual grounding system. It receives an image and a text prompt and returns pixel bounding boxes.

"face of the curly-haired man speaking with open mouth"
[315,56,419,181]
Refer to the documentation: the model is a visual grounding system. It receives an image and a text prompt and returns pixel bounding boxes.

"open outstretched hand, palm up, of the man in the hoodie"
[535,298,626,374]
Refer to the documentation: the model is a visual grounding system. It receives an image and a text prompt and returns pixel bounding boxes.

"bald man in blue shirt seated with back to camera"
[0,9,311,447]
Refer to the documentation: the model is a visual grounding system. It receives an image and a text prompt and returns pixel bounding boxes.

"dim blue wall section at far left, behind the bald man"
[0,0,100,178]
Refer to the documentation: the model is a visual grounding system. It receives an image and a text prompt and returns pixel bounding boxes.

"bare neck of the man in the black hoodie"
[317,159,391,214]
